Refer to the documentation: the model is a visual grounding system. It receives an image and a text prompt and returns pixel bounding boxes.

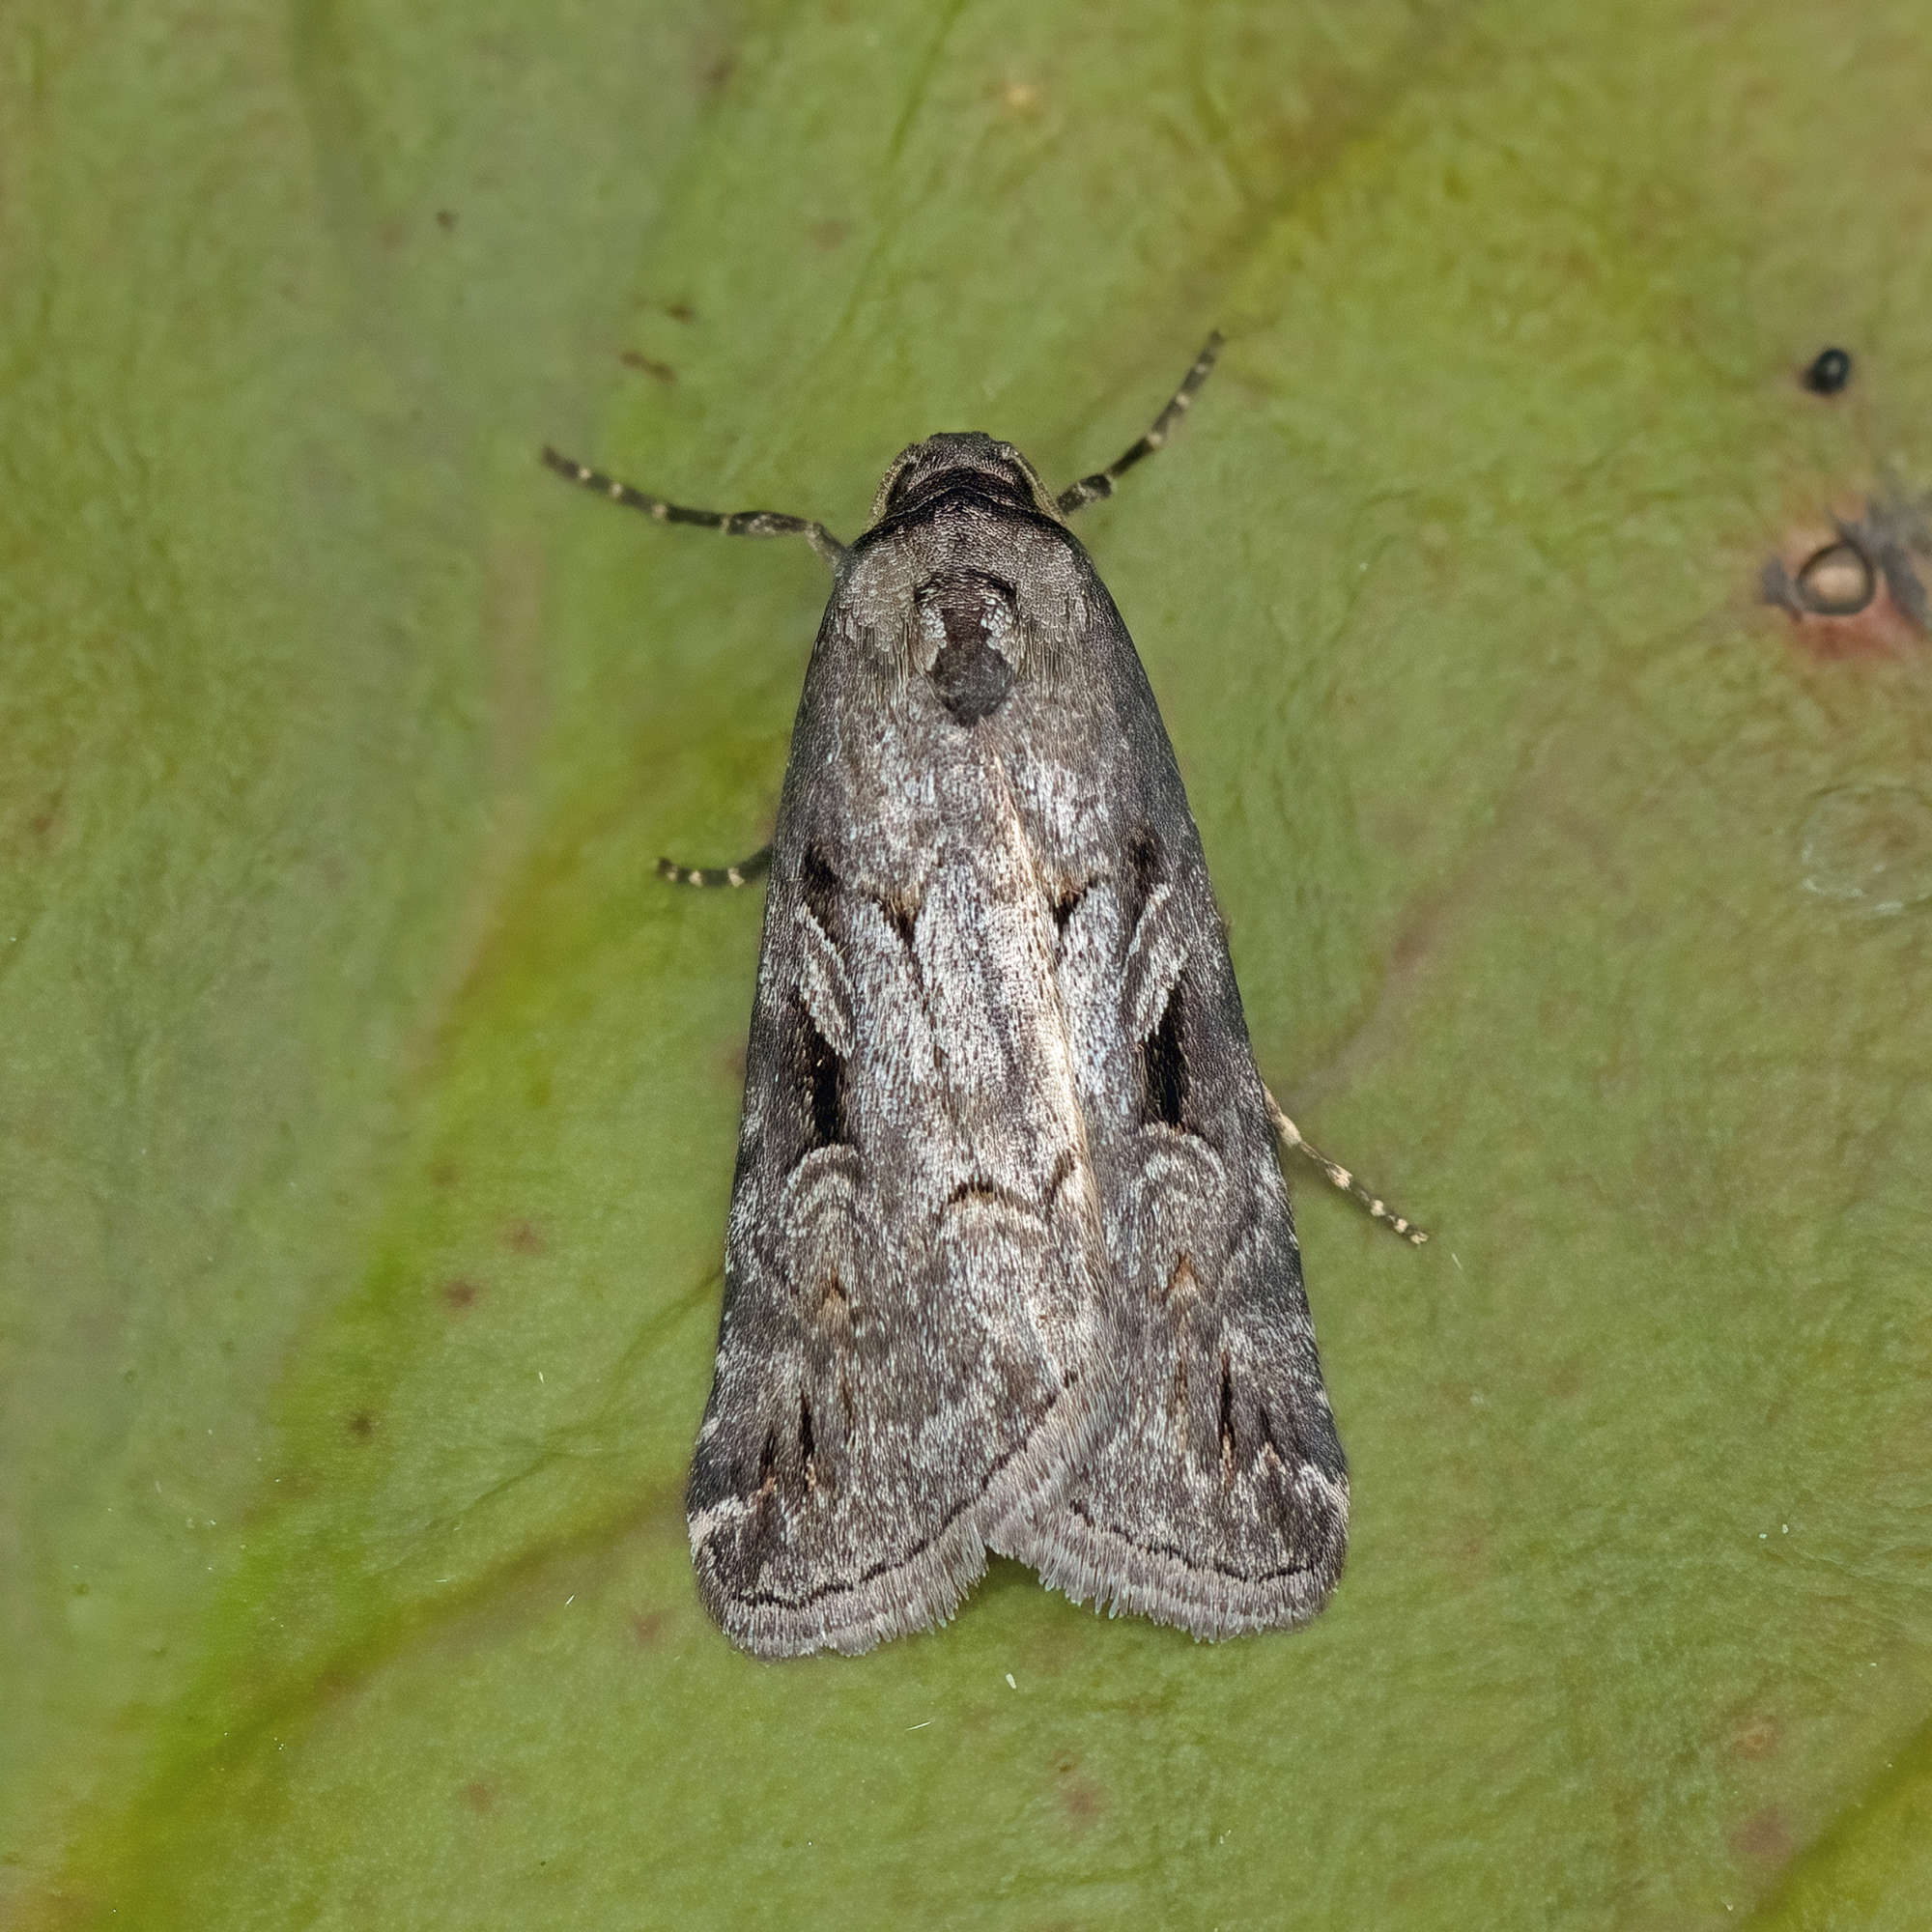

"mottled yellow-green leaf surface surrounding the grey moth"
[0,0,1932,1932]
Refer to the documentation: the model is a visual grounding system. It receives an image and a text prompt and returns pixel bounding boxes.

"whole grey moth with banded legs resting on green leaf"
[543,336,1424,1658]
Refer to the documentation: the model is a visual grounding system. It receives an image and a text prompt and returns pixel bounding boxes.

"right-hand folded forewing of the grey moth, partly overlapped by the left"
[993,607,1349,1638]
